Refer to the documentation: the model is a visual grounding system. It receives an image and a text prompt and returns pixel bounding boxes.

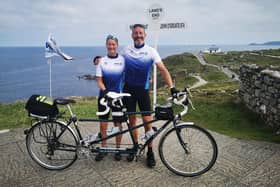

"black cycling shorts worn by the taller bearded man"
[123,85,152,116]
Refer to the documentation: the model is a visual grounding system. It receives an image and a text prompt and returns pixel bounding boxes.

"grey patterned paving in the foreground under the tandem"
[0,123,280,187]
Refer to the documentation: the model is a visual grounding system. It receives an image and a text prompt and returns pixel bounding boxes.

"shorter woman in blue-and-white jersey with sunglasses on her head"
[95,35,124,161]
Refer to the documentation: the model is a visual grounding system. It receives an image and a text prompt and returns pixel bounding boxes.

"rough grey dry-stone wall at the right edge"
[239,65,280,132]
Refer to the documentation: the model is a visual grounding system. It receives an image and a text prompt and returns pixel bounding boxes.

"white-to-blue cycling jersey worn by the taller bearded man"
[123,45,161,90]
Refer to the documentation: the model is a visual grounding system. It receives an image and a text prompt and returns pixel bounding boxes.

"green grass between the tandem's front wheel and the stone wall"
[184,95,280,143]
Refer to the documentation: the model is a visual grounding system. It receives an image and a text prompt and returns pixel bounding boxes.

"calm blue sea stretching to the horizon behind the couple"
[0,45,280,103]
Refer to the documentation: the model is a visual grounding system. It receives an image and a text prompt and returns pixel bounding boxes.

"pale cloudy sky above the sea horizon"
[0,0,280,46]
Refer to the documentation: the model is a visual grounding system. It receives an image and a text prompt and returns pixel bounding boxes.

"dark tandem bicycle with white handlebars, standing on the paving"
[25,88,218,177]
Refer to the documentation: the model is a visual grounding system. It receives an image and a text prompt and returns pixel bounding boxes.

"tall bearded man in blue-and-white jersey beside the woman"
[123,24,177,168]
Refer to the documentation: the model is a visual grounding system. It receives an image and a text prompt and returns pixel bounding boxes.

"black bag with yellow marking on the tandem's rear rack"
[25,95,58,117]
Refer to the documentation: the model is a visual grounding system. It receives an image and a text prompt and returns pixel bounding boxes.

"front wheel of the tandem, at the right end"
[159,123,218,177]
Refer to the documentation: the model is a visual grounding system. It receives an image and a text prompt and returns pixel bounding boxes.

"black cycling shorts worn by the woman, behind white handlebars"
[98,97,126,122]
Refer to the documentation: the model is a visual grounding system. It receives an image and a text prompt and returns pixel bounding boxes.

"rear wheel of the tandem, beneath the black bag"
[26,121,78,170]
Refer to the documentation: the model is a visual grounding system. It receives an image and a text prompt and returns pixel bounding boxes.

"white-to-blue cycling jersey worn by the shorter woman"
[96,55,125,92]
